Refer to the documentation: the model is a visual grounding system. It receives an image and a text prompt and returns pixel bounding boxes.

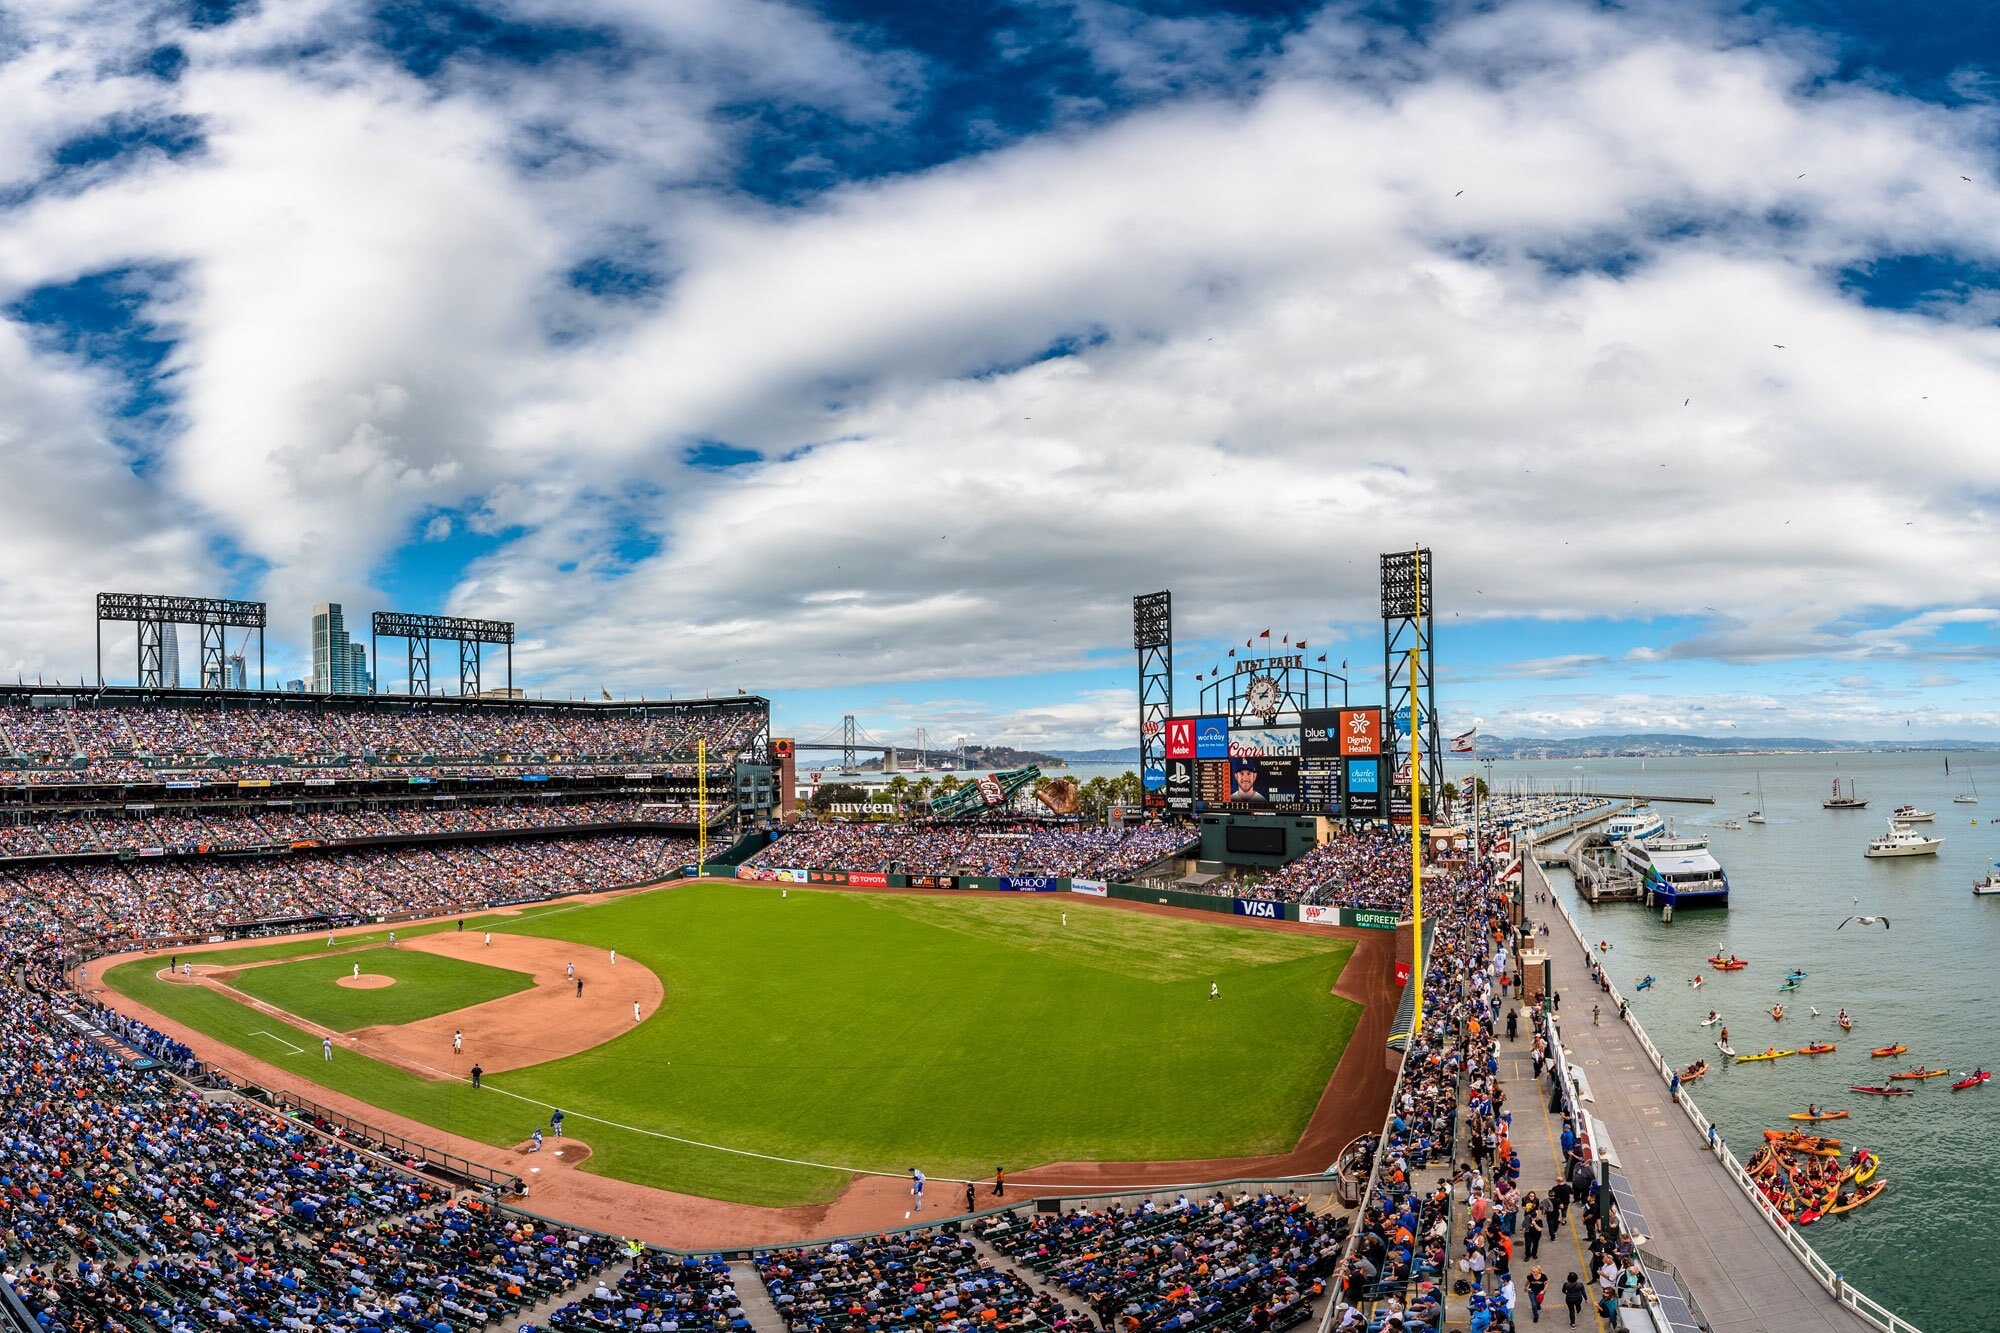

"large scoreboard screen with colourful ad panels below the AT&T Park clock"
[1166,709,1382,819]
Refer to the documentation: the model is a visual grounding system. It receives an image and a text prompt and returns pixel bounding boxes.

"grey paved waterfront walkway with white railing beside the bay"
[1510,875,1876,1333]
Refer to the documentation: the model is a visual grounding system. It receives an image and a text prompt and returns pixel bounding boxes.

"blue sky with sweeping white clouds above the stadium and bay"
[0,0,2000,747]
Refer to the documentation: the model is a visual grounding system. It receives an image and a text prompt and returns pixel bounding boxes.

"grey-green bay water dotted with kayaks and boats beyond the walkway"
[1496,753,2000,1333]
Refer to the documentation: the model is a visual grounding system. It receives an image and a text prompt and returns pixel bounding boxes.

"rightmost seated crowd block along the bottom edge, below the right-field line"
[974,1193,1346,1333]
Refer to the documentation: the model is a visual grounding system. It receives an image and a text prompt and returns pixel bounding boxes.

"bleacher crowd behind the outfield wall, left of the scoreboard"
[744,823,1196,879]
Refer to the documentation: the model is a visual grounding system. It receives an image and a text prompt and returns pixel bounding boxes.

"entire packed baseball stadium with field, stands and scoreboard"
[0,572,1508,1333]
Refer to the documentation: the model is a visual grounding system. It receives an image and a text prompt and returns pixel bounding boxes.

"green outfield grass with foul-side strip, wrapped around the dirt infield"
[110,885,1360,1205]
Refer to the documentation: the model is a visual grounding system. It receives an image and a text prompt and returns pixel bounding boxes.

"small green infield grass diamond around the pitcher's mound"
[230,949,534,1033]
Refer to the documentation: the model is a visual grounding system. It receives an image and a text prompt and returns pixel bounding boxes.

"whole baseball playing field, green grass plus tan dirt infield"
[104,883,1362,1205]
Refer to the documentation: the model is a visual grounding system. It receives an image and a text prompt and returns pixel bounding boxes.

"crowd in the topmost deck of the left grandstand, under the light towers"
[0,699,764,785]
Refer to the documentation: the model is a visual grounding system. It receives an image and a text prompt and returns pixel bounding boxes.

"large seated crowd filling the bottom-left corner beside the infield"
[0,964,616,1333]
